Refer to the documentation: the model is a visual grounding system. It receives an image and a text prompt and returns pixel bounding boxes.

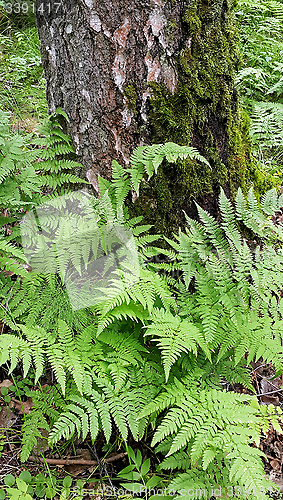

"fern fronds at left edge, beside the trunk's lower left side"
[0,109,86,276]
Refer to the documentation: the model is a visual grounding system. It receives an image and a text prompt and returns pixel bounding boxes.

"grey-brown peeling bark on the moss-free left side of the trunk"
[36,0,204,178]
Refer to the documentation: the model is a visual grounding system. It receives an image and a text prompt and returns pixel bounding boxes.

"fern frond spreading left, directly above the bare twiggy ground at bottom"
[50,362,160,443]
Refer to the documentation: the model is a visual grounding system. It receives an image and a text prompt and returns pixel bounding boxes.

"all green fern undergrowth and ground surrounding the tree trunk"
[0,0,283,500]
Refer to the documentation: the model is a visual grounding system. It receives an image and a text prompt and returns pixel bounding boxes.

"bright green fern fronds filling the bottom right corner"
[150,380,281,498]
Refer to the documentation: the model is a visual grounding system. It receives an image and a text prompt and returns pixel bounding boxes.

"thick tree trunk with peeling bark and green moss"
[35,0,268,231]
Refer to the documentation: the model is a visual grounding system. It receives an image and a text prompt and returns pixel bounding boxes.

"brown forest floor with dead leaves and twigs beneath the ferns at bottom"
[0,360,283,498]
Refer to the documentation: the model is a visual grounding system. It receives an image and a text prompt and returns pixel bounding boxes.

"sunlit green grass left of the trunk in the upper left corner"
[0,23,47,118]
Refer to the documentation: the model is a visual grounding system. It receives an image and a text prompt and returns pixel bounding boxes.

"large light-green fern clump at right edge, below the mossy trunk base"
[155,189,283,373]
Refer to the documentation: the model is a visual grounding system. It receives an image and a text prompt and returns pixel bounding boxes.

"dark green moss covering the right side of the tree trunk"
[132,0,272,234]
